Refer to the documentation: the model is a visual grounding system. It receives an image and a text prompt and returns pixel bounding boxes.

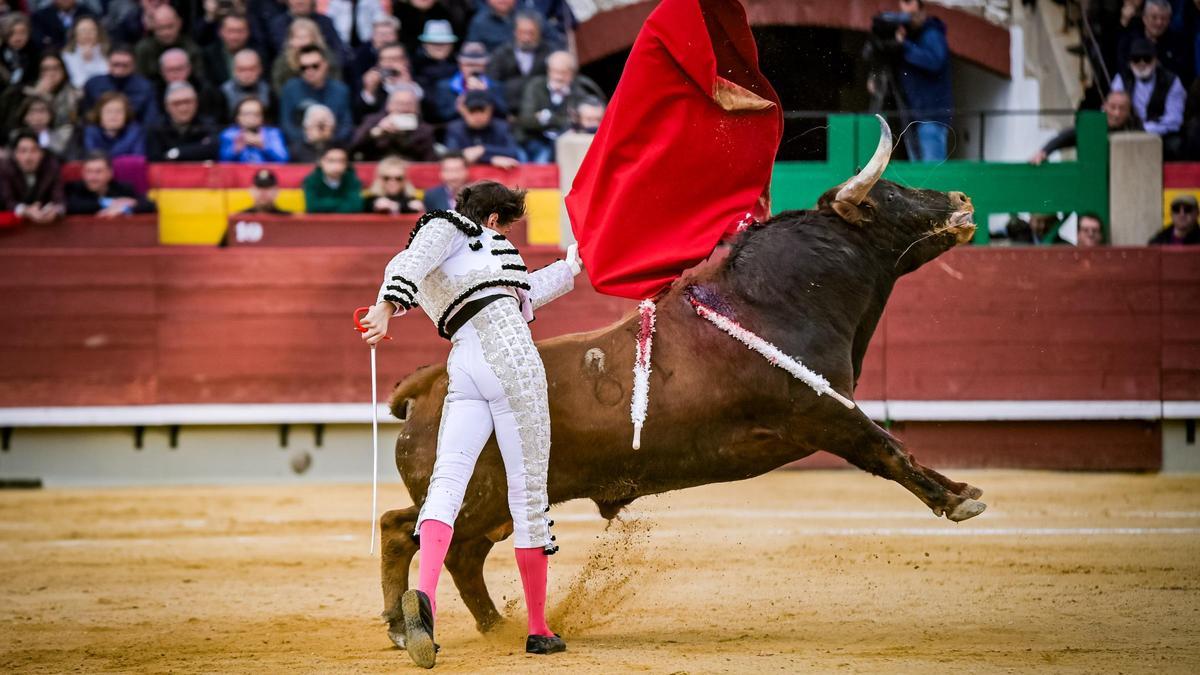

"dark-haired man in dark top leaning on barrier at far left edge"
[0,131,66,223]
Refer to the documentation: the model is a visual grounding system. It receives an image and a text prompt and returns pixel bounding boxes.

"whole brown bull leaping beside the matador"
[380,118,985,645]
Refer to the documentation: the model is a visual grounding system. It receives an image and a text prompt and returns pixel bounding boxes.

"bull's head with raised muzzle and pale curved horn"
[817,115,976,270]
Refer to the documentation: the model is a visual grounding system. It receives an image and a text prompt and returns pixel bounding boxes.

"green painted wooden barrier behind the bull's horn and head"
[770,112,1109,244]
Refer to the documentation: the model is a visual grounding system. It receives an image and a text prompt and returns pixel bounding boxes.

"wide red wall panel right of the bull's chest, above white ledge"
[886,249,1162,400]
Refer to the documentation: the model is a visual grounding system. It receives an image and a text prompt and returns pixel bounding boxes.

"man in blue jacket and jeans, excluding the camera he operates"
[895,0,954,162]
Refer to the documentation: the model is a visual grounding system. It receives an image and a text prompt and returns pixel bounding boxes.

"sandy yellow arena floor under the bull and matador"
[0,471,1200,673]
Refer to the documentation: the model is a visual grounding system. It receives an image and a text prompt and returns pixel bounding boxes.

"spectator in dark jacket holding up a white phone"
[352,88,437,162]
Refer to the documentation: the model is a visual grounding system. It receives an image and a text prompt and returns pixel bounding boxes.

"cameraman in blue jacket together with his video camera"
[866,0,954,162]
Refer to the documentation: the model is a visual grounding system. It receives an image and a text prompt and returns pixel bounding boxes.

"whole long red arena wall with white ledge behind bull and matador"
[0,241,1200,476]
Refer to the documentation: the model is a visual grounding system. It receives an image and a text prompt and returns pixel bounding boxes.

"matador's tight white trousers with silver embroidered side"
[416,298,550,549]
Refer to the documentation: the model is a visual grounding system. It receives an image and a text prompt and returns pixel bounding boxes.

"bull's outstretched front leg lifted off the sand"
[827,410,986,522]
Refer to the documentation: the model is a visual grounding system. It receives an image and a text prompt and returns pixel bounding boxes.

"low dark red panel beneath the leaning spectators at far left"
[0,215,158,249]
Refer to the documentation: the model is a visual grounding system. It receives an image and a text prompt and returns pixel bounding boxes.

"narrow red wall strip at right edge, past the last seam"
[1162,248,1200,401]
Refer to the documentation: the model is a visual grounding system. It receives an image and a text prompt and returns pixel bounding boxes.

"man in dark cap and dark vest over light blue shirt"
[1112,38,1187,160]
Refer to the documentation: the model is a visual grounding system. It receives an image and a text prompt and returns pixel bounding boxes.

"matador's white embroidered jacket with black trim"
[377,210,577,340]
